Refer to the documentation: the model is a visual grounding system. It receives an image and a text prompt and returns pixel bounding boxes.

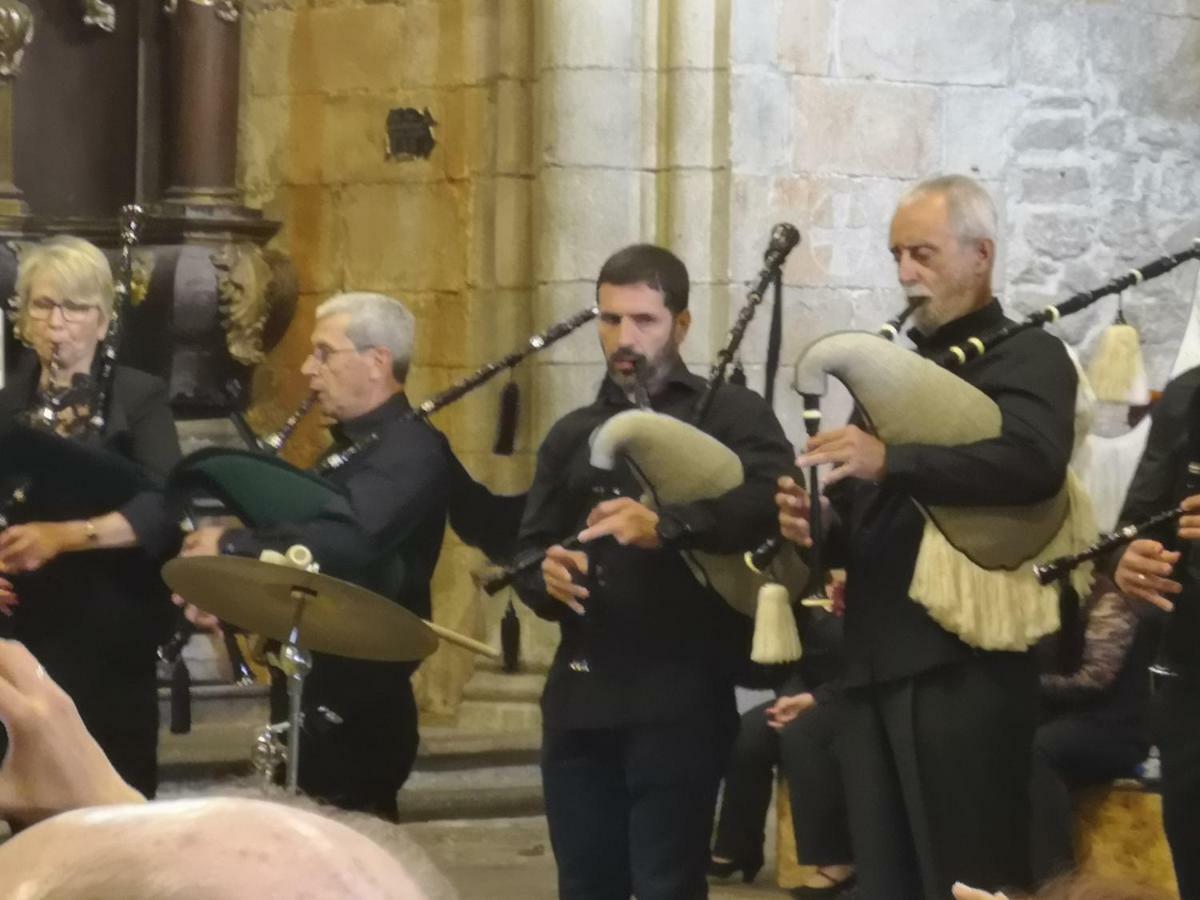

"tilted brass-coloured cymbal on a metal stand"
[162,557,438,662]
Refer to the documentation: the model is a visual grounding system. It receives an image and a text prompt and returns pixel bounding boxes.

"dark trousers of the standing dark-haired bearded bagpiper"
[541,713,737,900]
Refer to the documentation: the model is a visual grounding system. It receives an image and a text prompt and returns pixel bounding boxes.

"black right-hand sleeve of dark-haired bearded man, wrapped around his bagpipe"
[660,385,794,553]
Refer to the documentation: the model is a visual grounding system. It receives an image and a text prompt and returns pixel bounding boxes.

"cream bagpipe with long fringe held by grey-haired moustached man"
[751,240,1200,649]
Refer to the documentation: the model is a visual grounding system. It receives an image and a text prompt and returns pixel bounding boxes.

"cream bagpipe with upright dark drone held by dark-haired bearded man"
[484,223,808,662]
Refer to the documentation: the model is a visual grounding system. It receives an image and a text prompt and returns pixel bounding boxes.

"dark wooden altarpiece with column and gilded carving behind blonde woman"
[0,0,295,418]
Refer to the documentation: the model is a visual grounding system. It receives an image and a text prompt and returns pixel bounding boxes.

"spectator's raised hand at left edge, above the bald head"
[0,641,145,824]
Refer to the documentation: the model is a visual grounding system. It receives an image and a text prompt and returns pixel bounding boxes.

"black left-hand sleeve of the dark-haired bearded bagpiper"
[514,419,584,622]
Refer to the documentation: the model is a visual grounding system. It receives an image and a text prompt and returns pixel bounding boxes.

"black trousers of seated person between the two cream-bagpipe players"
[713,702,853,865]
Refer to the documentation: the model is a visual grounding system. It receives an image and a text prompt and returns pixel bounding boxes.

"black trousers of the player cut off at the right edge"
[1153,677,1200,900]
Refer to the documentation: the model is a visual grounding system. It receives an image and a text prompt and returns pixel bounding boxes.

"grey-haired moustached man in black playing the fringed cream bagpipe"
[776,176,1076,900]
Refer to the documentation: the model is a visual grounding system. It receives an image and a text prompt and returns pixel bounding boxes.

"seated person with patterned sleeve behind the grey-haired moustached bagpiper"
[1030,577,1154,882]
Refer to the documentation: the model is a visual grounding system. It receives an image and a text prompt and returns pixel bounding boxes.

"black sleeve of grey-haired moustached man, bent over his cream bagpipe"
[884,336,1078,505]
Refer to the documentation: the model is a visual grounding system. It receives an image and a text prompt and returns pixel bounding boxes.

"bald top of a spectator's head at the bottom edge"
[0,798,427,900]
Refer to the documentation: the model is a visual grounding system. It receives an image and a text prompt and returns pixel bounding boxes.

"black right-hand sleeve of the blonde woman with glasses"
[116,378,181,559]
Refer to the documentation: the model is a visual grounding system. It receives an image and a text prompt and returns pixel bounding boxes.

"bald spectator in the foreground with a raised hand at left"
[0,641,446,900]
